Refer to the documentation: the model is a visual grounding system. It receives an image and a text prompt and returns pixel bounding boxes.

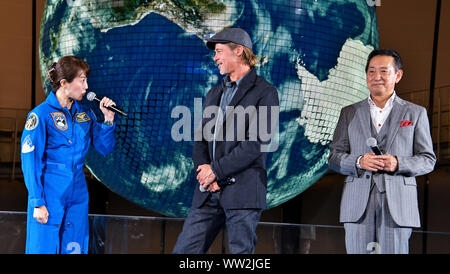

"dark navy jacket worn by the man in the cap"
[192,69,279,209]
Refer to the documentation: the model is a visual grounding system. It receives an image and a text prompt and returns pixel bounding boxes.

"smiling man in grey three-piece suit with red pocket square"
[328,49,436,254]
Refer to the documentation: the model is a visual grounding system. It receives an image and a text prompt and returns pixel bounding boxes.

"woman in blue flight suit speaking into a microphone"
[21,56,115,253]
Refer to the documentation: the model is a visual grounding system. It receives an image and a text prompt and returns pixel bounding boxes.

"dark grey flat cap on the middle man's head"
[206,28,252,50]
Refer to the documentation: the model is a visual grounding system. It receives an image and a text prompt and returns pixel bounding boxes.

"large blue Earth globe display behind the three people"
[39,0,378,217]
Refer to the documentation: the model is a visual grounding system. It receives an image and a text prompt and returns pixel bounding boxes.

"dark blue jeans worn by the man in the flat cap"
[173,192,262,254]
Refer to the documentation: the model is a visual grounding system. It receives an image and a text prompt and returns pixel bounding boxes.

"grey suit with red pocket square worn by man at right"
[328,96,436,253]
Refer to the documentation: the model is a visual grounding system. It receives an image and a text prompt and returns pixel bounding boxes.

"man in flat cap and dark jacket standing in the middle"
[173,28,279,254]
